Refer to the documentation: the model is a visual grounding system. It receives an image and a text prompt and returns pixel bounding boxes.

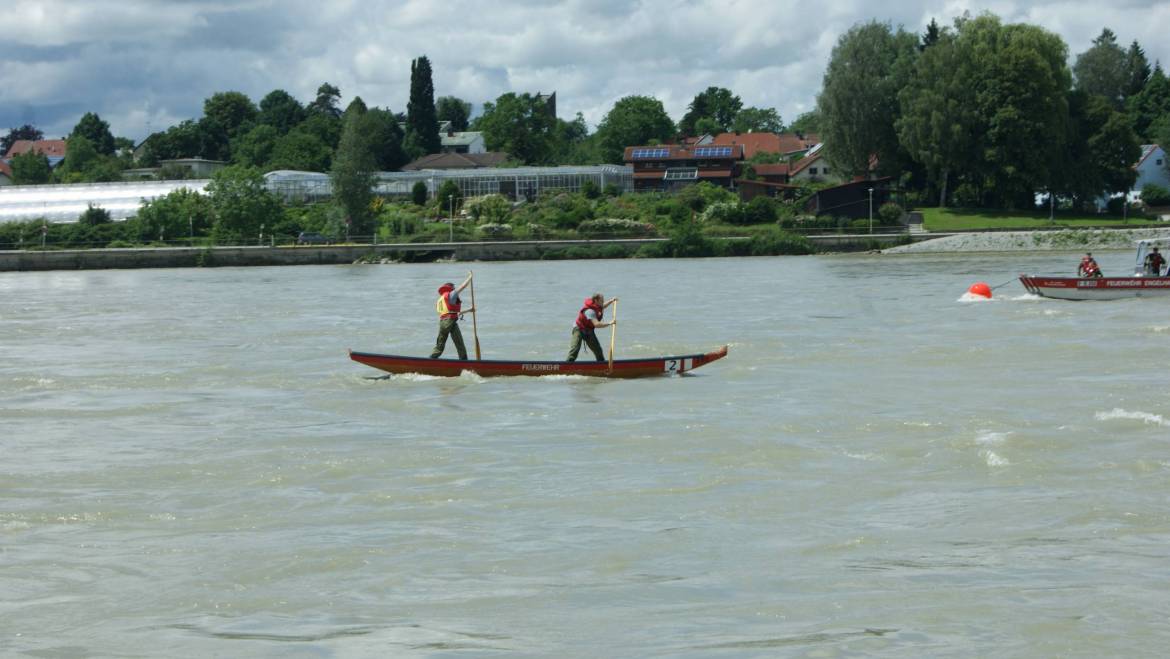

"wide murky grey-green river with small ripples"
[0,253,1170,658]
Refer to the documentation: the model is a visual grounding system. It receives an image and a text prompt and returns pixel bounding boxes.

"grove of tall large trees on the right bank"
[817,13,1170,208]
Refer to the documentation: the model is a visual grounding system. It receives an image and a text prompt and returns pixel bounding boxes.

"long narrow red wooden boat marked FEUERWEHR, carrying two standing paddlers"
[350,345,728,378]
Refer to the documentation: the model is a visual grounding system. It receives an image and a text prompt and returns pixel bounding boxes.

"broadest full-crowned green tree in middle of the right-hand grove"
[898,14,1071,206]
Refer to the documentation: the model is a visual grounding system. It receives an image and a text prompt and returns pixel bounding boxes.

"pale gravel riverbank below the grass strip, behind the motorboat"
[881,228,1170,254]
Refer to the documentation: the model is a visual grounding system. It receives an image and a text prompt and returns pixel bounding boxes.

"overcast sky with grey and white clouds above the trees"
[0,0,1170,142]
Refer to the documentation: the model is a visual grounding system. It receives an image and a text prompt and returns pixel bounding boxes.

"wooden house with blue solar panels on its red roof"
[622,144,743,192]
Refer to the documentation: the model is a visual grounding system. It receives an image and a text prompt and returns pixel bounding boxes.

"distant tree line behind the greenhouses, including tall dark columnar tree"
[0,56,784,184]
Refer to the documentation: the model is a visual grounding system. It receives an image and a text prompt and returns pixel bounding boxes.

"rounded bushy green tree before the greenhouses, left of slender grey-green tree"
[207,165,283,243]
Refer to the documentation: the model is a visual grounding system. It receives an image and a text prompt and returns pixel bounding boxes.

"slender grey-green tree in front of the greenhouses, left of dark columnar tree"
[329,97,377,235]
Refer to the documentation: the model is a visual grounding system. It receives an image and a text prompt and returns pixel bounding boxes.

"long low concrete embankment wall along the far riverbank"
[0,234,904,272]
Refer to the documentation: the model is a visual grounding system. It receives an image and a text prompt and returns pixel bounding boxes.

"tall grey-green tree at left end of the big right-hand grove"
[817,21,918,178]
